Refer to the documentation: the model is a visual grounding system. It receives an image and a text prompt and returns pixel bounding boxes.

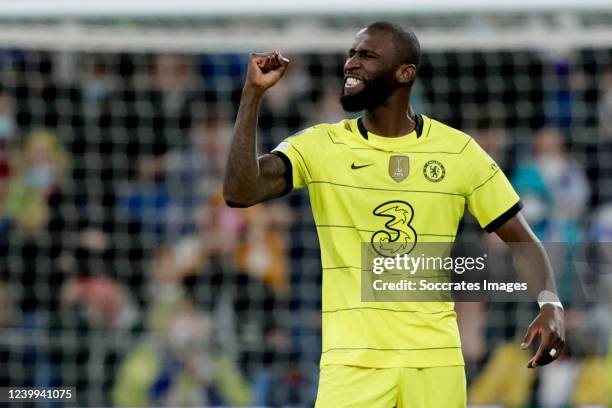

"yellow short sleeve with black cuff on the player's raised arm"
[271,127,321,192]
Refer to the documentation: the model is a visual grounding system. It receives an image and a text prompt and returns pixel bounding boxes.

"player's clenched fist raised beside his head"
[245,51,289,91]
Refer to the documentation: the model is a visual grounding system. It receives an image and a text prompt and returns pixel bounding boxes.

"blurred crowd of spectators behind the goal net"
[0,50,612,407]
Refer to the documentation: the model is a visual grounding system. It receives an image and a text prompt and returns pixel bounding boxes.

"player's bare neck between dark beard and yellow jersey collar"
[363,92,416,137]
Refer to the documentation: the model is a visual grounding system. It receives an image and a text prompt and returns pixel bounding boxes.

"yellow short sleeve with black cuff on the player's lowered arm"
[463,139,522,232]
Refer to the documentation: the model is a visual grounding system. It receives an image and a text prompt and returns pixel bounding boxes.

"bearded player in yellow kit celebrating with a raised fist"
[224,22,564,408]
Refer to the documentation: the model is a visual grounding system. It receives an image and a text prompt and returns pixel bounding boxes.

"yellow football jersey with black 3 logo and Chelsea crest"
[273,115,521,368]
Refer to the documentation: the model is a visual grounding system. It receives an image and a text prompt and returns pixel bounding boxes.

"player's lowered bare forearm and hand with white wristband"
[495,213,565,368]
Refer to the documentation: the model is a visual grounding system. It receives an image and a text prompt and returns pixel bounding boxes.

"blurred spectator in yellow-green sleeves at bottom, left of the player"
[113,299,251,406]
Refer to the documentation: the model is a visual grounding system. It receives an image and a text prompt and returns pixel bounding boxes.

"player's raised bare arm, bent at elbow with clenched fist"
[223,52,289,207]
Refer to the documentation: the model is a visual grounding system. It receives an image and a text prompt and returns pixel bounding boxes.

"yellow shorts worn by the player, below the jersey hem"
[315,365,466,408]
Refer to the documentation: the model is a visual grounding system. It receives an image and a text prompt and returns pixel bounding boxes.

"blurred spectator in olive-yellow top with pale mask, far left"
[5,130,68,234]
